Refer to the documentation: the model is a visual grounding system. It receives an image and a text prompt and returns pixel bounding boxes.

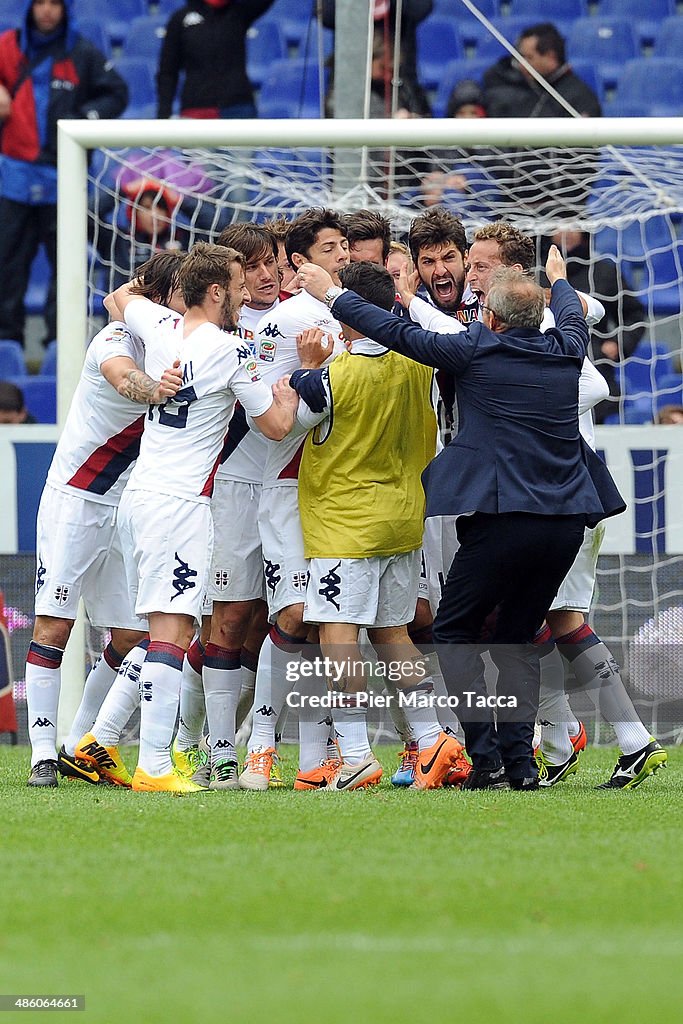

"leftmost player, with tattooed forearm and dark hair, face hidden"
[26,253,184,786]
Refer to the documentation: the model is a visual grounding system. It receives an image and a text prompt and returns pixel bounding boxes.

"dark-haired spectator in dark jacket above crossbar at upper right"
[483,22,602,118]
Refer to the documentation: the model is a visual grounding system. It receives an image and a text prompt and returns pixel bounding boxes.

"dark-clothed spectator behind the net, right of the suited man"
[546,230,646,423]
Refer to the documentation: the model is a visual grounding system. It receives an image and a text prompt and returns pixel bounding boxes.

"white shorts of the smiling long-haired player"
[207,479,265,601]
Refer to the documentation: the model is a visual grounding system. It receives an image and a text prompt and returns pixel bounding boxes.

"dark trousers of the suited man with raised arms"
[433,512,585,778]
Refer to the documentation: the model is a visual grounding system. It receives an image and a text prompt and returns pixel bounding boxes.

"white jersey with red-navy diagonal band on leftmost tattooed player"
[47,321,146,506]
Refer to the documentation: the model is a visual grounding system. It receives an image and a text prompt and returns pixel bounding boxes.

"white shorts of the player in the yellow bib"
[303,549,420,628]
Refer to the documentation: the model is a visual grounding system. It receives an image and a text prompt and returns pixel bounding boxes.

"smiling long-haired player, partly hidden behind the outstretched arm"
[174,223,280,790]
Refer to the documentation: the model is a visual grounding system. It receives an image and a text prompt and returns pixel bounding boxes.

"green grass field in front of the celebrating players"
[0,746,683,1024]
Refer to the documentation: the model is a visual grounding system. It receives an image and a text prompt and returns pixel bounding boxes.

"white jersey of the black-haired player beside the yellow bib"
[256,292,344,487]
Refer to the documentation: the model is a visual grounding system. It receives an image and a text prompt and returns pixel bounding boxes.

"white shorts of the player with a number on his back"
[119,490,213,622]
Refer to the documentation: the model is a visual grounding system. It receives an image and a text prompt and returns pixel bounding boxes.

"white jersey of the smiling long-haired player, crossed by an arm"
[216,299,280,483]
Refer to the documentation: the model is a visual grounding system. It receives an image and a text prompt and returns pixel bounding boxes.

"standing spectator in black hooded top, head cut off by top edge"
[157,0,273,118]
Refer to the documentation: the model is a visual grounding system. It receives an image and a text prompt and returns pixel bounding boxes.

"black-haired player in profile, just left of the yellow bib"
[240,209,349,791]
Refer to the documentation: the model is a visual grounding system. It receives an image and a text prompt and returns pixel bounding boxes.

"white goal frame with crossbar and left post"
[57,118,683,716]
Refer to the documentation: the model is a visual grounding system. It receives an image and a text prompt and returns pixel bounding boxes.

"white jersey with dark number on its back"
[125,299,272,503]
